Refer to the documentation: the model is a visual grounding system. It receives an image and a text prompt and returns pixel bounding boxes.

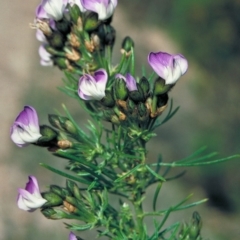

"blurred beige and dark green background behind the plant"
[0,0,240,240]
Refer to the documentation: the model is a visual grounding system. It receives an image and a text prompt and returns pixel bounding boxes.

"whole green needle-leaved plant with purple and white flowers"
[11,0,238,240]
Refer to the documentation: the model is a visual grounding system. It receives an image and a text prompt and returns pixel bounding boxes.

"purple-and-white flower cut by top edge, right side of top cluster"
[81,0,117,20]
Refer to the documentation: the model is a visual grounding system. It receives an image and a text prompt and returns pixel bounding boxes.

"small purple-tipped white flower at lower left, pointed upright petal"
[17,176,47,212]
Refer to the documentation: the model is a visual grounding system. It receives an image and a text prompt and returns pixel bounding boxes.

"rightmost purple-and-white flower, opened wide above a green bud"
[148,52,188,84]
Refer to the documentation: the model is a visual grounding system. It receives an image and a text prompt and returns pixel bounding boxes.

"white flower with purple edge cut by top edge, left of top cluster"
[36,0,68,21]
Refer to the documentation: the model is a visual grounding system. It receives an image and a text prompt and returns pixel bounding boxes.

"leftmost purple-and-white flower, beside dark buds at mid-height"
[10,106,42,147]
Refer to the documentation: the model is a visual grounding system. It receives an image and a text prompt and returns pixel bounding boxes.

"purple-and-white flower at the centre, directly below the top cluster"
[78,69,108,100]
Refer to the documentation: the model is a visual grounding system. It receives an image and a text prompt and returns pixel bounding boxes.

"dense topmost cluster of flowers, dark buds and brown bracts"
[32,0,117,71]
